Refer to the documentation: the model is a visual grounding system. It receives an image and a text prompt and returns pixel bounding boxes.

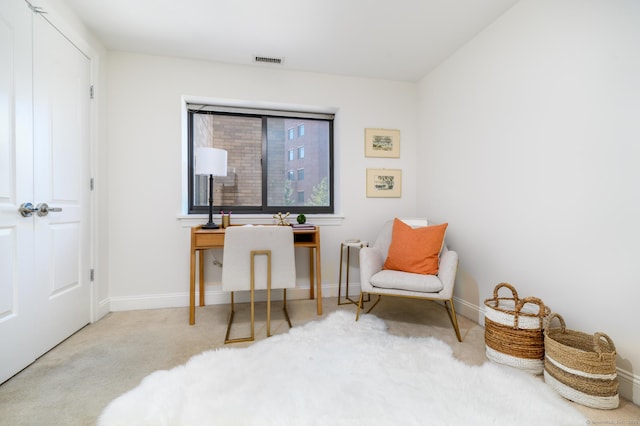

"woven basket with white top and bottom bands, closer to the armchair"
[484,283,550,375]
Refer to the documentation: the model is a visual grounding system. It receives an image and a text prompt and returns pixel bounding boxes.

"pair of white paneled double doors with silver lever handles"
[0,0,90,383]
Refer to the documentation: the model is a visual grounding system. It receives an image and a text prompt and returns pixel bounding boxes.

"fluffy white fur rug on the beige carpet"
[98,311,586,426]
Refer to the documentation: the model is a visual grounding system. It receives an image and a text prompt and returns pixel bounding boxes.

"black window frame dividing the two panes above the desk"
[186,103,336,215]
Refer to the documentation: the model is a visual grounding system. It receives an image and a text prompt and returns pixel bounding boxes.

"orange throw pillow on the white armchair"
[383,218,448,275]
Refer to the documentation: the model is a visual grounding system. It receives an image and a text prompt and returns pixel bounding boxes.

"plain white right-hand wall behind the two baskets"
[417,0,640,403]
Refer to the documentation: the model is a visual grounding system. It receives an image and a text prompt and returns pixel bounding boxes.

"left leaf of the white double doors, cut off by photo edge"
[0,0,37,383]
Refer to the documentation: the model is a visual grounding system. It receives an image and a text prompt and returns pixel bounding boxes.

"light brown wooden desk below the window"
[189,225,322,325]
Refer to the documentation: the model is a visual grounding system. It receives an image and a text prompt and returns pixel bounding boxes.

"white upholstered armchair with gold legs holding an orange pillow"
[356,219,462,342]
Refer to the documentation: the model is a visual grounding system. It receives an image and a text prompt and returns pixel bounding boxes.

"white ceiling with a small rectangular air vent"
[57,0,518,81]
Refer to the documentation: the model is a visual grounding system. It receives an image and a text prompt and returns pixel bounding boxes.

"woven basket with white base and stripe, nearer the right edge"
[544,314,620,410]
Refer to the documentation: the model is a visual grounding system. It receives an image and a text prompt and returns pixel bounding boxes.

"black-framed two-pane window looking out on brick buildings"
[187,105,334,214]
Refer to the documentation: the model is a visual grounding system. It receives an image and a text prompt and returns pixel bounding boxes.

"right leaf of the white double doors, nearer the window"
[33,10,90,358]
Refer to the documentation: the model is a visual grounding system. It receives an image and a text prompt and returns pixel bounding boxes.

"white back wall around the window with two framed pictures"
[106,52,418,308]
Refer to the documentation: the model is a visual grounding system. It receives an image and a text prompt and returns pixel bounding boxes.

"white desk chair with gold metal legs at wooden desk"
[222,226,296,343]
